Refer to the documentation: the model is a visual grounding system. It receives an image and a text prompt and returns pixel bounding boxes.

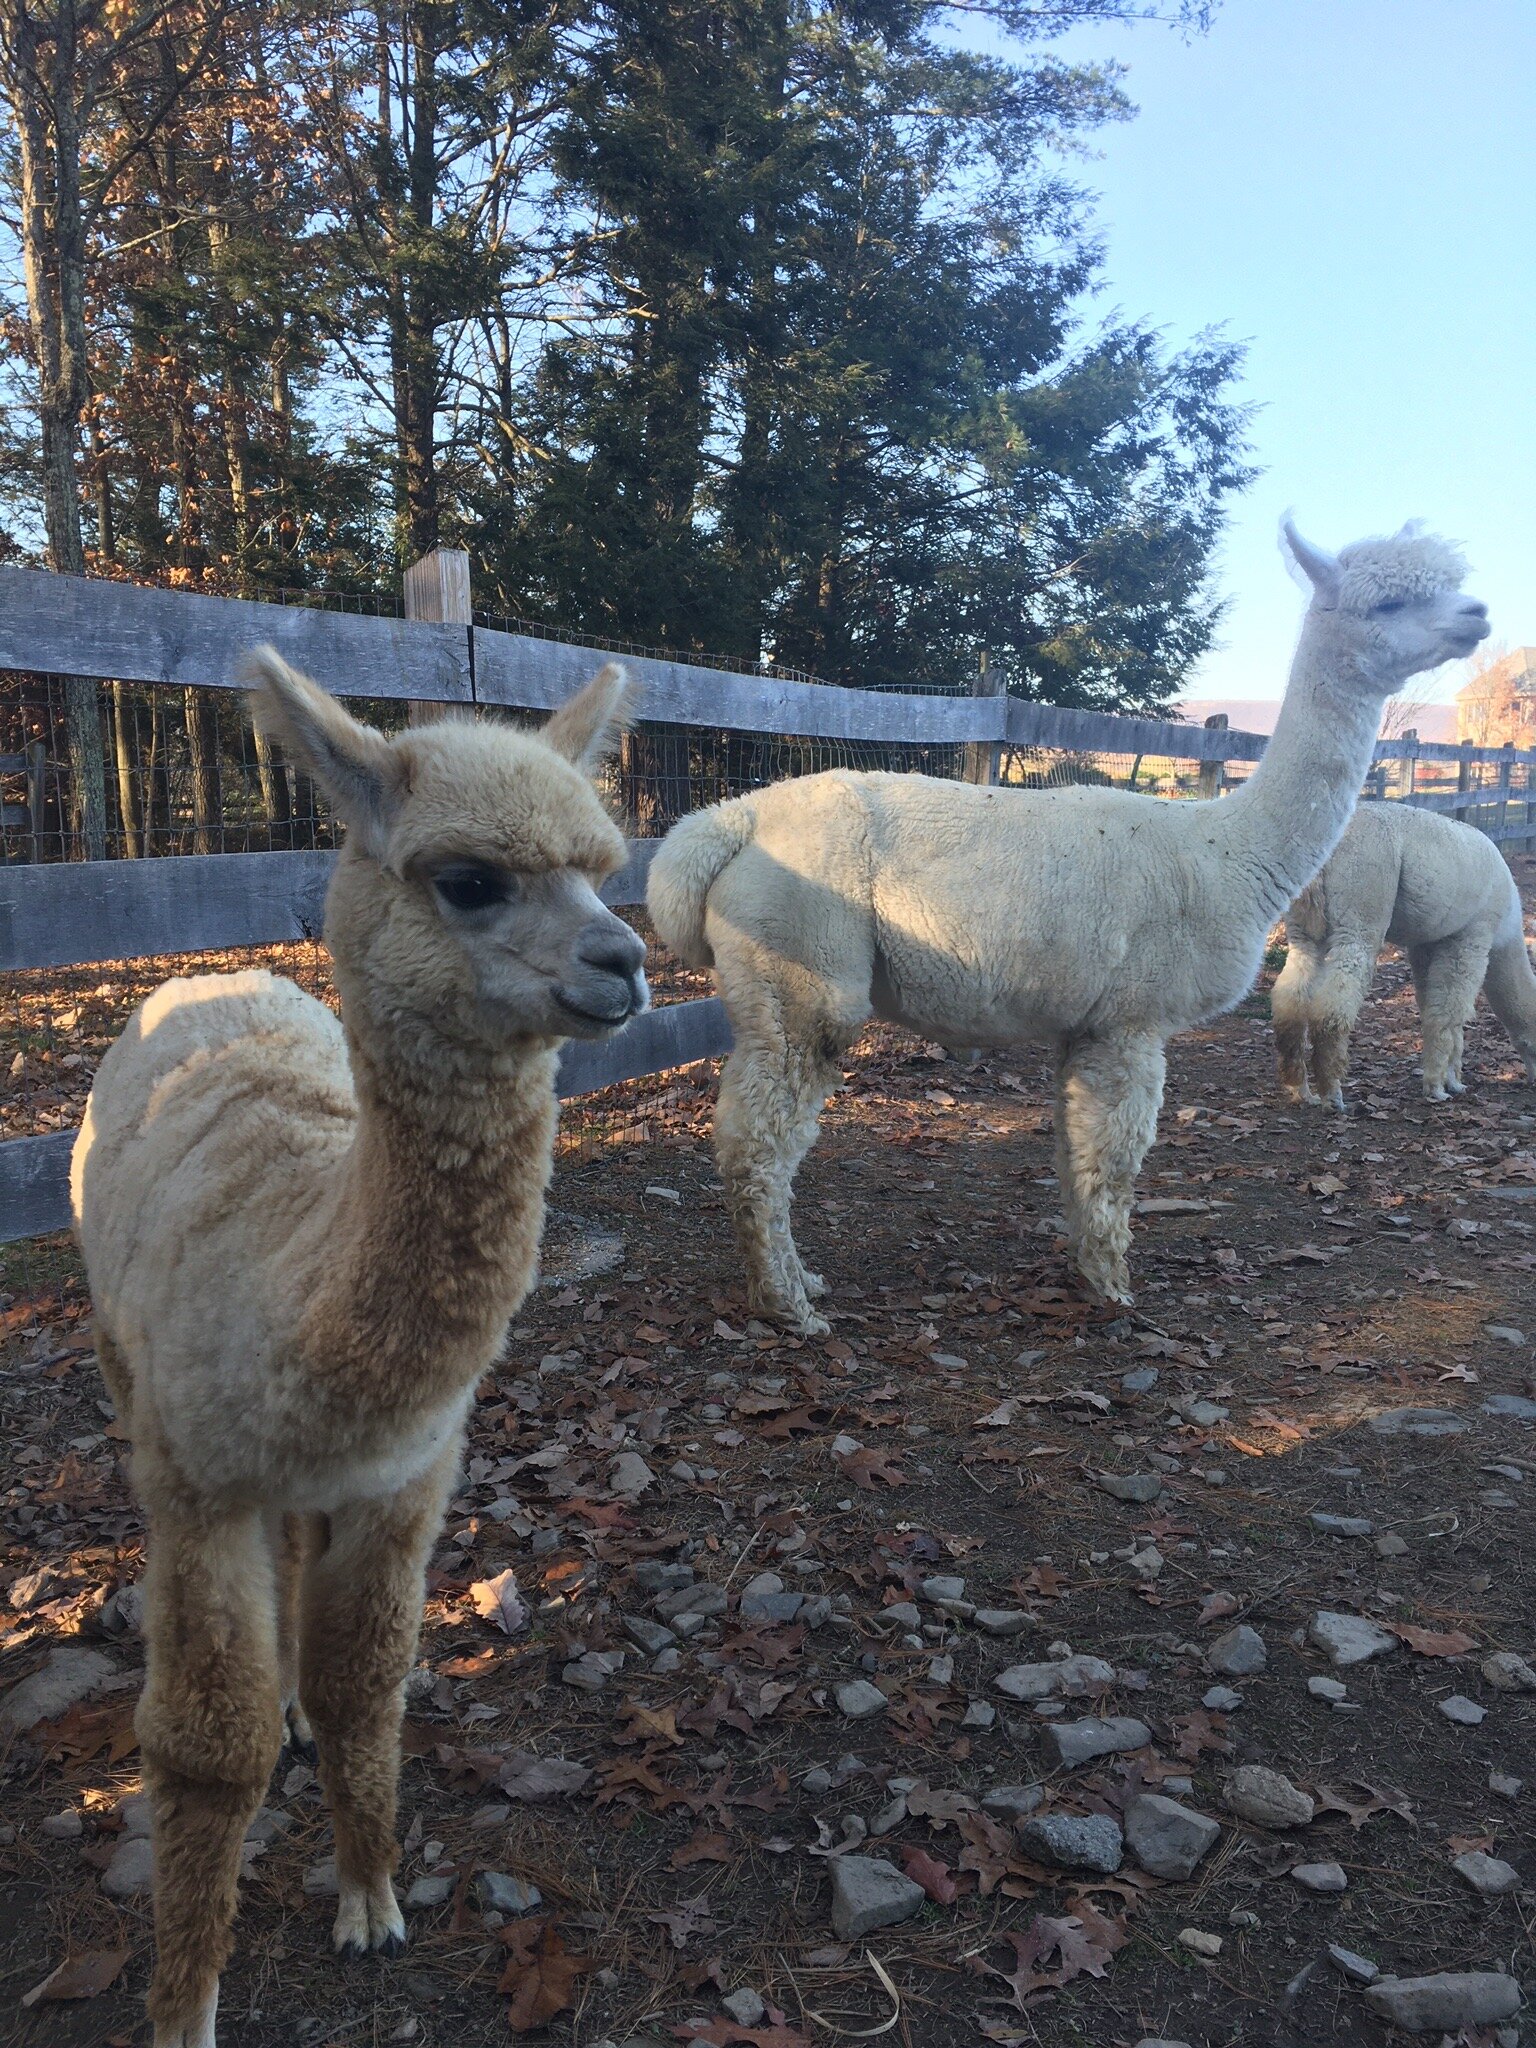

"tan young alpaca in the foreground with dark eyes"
[72,649,647,2048]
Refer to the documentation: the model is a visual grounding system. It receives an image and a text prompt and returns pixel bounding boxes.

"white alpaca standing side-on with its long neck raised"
[649,528,1487,1333]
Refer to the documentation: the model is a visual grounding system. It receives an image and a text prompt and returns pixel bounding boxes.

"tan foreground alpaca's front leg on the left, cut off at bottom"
[135,1509,279,2048]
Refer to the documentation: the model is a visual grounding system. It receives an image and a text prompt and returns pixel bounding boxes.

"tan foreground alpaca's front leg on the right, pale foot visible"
[299,1444,459,1954]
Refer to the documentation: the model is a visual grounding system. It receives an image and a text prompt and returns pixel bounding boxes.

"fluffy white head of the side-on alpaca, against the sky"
[1284,520,1489,696]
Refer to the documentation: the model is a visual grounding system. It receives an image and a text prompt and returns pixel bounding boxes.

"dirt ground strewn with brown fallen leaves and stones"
[0,872,1536,2048]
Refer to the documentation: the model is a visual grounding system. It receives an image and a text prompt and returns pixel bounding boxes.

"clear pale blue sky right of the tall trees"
[978,0,1536,698]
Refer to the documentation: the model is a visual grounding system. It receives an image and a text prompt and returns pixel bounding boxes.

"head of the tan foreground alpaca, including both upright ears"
[250,647,649,1053]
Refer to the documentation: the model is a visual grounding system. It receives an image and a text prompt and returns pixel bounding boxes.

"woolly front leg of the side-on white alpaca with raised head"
[1057,1036,1165,1303]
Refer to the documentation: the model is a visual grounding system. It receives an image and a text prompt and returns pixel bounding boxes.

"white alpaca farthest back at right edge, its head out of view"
[1272,803,1536,1110]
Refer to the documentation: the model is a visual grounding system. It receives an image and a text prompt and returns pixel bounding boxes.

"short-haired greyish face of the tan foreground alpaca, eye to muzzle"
[418,856,651,1038]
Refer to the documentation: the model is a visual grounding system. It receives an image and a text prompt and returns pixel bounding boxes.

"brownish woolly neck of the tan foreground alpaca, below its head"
[307,1018,557,1409]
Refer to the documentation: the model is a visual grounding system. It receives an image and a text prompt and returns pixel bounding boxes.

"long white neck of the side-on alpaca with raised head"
[1210,612,1380,928]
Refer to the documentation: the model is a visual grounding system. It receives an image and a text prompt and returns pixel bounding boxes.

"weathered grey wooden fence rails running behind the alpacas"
[0,569,1536,1241]
